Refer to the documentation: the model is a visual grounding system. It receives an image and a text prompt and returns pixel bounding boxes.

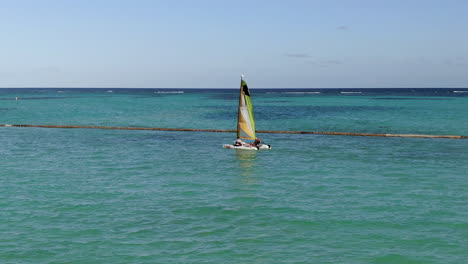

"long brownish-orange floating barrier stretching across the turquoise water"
[0,124,468,139]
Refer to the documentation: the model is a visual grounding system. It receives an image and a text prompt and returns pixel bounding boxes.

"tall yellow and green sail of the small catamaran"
[237,79,255,139]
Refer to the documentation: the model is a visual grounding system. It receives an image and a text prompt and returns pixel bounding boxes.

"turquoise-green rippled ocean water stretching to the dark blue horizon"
[0,88,468,264]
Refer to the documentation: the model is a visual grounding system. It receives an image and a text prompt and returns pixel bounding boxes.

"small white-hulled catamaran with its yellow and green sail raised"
[223,75,271,150]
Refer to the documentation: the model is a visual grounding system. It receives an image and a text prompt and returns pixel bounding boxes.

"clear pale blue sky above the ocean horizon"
[0,0,468,88]
